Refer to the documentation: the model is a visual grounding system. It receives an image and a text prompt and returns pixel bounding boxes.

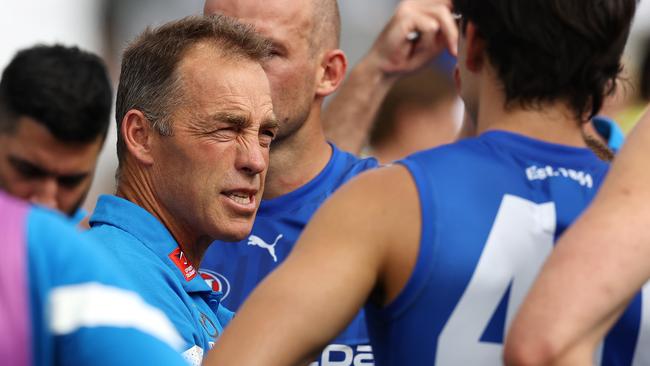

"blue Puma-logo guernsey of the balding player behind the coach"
[201,145,378,366]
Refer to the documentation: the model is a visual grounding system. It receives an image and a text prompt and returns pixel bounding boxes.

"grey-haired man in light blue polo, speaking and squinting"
[88,16,277,365]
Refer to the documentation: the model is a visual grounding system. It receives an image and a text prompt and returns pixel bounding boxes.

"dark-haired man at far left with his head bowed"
[0,45,113,222]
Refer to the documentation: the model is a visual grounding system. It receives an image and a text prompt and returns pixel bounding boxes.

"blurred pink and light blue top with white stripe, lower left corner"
[0,192,185,366]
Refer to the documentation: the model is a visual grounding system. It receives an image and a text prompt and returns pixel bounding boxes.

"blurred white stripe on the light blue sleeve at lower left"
[49,282,184,350]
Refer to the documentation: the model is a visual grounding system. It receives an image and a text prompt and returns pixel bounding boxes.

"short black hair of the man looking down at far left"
[0,45,113,143]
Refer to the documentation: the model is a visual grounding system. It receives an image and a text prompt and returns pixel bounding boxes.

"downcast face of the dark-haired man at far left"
[0,116,103,215]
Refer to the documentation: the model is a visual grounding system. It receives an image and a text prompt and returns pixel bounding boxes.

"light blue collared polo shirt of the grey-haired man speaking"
[87,195,233,365]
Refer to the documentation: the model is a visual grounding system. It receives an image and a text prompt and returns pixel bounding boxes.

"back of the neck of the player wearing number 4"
[477,83,586,147]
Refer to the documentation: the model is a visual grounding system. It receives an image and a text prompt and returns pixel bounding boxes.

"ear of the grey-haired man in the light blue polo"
[120,109,156,165]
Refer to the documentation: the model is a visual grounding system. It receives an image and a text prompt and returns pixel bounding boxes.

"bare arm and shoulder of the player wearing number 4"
[207,167,419,366]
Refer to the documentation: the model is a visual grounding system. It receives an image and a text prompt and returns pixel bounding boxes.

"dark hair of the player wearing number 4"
[453,0,637,121]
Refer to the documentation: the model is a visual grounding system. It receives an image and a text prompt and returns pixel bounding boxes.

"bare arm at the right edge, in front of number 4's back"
[505,105,650,365]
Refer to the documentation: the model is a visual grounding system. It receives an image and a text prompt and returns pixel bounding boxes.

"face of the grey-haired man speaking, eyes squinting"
[152,44,277,241]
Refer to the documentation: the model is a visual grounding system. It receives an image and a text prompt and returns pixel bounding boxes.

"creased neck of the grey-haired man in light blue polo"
[116,164,208,268]
